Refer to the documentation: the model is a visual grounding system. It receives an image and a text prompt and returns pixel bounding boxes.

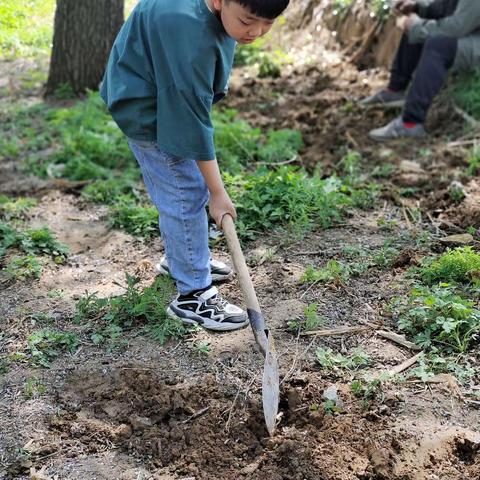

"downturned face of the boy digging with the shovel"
[212,0,275,44]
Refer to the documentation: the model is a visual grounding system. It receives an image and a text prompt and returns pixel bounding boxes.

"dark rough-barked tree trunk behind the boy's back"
[46,0,124,95]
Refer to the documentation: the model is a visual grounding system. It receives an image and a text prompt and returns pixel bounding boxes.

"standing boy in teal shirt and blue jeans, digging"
[101,0,289,331]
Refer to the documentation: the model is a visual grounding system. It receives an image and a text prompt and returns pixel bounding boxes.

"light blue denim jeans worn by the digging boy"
[128,140,212,295]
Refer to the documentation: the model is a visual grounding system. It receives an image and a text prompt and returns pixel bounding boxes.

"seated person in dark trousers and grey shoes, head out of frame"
[361,0,480,141]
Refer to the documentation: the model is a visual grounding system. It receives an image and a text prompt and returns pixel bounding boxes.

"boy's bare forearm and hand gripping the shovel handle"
[197,160,237,228]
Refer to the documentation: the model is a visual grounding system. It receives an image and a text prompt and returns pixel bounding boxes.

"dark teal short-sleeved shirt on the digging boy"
[100,0,235,160]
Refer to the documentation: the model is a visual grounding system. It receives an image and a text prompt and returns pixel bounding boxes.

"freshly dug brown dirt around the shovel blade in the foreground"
[36,366,480,480]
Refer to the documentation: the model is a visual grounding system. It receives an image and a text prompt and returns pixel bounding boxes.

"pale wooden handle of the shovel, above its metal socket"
[222,214,260,312]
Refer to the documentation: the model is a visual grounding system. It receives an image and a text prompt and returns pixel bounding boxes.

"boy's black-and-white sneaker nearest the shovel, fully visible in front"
[167,287,249,332]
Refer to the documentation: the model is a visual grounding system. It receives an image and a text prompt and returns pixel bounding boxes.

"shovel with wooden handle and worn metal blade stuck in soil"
[222,214,280,436]
